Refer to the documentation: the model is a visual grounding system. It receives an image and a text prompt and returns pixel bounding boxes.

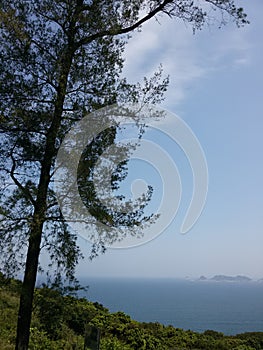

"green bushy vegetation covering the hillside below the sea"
[0,275,263,350]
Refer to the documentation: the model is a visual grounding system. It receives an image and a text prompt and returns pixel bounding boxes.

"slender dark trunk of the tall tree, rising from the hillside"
[15,45,74,350]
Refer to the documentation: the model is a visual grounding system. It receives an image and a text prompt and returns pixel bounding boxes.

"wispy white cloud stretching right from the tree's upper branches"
[124,9,256,106]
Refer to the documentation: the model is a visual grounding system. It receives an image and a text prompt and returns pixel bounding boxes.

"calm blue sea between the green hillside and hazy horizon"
[80,278,263,334]
